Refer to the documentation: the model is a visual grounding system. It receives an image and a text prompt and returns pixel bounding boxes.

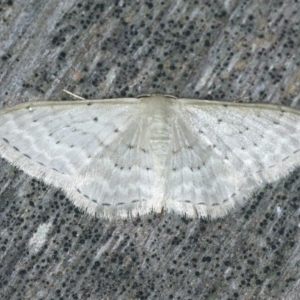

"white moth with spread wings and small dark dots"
[0,95,300,218]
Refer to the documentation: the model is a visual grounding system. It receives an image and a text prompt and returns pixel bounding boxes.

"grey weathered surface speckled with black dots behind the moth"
[0,0,300,299]
